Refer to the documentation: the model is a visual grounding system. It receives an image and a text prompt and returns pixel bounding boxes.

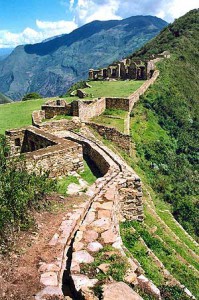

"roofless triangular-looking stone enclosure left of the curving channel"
[6,126,83,177]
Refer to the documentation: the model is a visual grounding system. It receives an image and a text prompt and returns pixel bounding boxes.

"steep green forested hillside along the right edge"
[132,9,199,240]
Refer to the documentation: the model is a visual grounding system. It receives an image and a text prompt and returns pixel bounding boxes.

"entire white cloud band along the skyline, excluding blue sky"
[0,0,198,48]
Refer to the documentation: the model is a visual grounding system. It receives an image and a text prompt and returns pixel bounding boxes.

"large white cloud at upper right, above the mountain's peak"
[71,0,198,25]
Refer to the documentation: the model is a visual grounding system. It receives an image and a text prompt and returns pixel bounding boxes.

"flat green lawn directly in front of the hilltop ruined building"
[84,80,144,98]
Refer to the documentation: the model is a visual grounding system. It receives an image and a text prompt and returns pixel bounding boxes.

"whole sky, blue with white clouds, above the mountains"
[0,0,199,48]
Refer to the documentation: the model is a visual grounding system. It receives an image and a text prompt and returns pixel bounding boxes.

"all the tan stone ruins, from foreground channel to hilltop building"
[6,54,171,300]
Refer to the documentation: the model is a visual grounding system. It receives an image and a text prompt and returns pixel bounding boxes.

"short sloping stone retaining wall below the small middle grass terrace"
[86,122,131,153]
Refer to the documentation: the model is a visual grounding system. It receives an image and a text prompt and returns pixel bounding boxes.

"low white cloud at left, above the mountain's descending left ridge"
[0,20,77,48]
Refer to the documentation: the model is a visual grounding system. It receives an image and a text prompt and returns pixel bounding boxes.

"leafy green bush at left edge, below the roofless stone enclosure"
[0,136,55,248]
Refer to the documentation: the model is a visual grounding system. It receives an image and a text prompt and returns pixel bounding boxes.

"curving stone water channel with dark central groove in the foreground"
[36,129,143,300]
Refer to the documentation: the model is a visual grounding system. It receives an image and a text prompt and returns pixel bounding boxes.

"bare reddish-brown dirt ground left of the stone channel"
[0,195,85,300]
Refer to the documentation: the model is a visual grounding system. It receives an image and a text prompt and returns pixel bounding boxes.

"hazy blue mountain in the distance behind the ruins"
[0,16,167,100]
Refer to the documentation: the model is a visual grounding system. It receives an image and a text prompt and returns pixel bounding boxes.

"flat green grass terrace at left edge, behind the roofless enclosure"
[0,97,76,134]
